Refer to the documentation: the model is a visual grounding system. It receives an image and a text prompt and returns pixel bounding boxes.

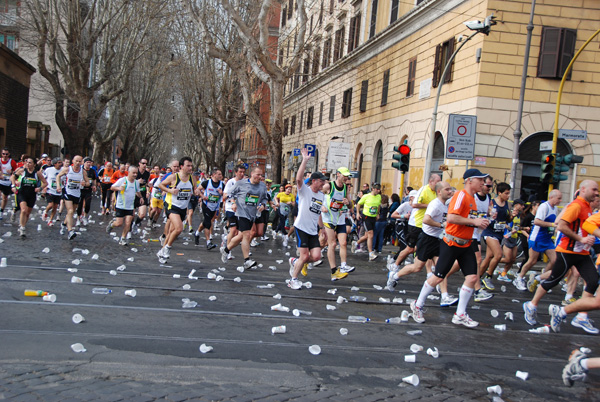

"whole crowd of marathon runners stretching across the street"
[0,148,600,385]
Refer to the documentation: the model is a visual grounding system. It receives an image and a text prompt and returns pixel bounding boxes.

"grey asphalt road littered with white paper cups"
[0,199,600,401]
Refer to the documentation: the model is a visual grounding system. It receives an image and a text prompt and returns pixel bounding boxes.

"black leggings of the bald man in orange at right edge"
[540,253,599,295]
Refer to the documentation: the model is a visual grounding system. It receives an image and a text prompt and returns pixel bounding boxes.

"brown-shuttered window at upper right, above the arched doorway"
[537,27,577,79]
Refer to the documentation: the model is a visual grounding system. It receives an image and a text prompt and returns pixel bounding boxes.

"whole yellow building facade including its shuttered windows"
[280,0,600,200]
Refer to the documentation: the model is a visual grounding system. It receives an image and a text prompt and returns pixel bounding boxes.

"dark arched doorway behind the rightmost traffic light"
[517,131,573,201]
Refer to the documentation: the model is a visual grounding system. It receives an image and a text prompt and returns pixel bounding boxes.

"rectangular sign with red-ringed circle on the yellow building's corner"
[446,114,477,160]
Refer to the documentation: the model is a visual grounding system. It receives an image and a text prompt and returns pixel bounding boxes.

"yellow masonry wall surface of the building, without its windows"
[284,0,600,199]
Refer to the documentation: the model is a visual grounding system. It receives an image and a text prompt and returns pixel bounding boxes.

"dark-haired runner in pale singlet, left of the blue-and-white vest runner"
[156,156,196,264]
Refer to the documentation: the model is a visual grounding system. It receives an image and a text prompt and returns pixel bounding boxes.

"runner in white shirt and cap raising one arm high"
[288,148,328,290]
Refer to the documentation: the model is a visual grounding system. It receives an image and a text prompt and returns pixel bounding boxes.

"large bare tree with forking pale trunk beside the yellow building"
[187,0,307,178]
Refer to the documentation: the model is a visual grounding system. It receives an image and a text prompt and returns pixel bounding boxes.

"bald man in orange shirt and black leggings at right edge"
[523,180,600,333]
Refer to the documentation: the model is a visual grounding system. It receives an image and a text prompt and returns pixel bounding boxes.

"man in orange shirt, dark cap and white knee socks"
[410,169,490,328]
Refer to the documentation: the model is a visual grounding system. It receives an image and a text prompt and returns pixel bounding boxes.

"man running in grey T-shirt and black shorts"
[221,167,268,269]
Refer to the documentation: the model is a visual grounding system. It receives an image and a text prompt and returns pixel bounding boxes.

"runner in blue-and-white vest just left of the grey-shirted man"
[194,169,225,250]
